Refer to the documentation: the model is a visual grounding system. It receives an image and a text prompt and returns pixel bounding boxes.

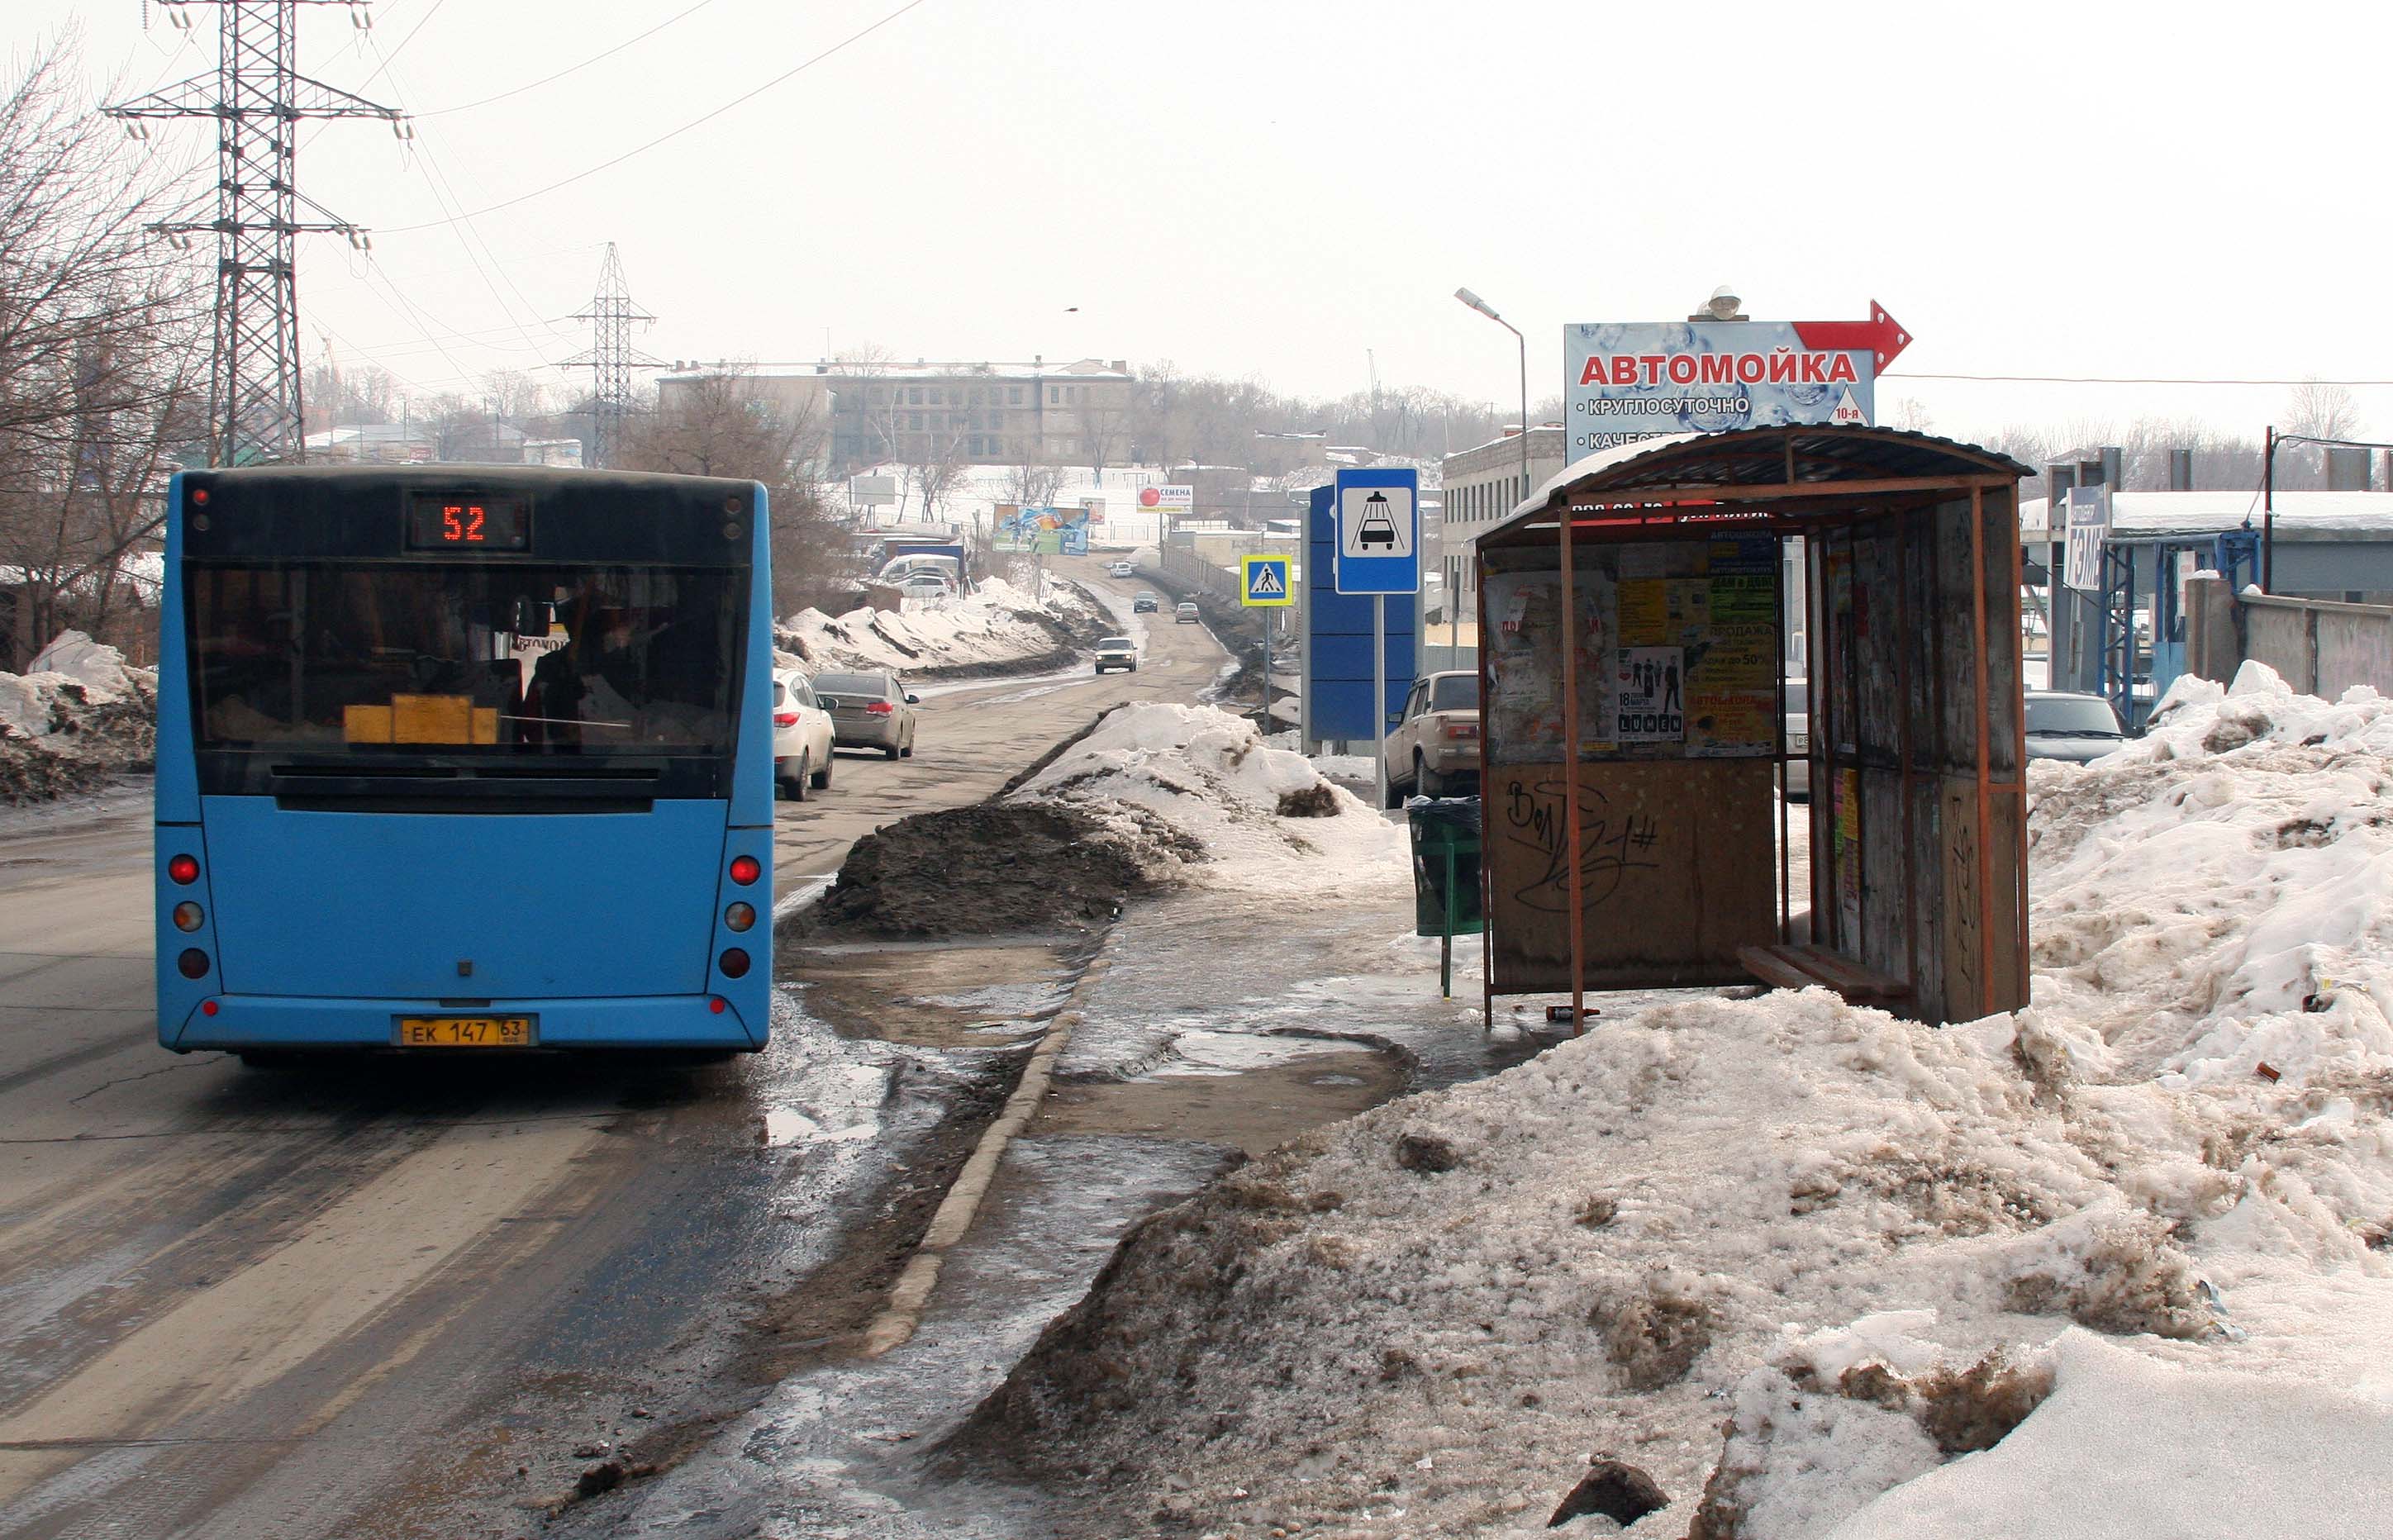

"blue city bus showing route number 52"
[158,466,773,1062]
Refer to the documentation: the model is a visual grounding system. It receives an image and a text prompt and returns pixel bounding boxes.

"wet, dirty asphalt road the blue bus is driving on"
[0,562,1223,1540]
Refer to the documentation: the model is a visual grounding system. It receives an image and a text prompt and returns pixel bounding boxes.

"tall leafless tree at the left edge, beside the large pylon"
[0,40,206,665]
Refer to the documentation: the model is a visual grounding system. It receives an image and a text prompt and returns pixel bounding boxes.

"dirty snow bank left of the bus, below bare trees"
[0,631,158,804]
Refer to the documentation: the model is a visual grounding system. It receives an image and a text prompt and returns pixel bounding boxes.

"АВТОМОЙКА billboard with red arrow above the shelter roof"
[1563,304,1910,462]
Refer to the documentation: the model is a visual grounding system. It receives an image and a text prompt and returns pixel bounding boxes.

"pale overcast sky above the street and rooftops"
[18,0,2393,447]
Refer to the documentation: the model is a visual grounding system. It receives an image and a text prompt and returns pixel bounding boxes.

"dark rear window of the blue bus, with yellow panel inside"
[189,562,745,760]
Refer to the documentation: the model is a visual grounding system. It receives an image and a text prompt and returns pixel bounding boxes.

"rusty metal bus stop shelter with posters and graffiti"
[1477,425,2029,1024]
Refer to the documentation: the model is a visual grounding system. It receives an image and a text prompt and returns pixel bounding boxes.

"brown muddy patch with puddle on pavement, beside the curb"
[1029,1030,1405,1155]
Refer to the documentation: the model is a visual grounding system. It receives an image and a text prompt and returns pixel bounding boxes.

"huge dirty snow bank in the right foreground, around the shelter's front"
[953,674,2393,1540]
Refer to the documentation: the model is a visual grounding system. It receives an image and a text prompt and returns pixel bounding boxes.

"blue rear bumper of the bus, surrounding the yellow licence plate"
[158,995,768,1053]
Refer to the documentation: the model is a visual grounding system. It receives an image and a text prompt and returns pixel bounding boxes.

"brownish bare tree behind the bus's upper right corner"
[620,371,857,615]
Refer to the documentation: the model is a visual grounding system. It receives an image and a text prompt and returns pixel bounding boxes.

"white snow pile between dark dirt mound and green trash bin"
[1010,703,1412,892]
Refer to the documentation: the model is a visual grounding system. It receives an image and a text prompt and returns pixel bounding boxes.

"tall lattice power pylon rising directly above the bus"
[107,0,407,466]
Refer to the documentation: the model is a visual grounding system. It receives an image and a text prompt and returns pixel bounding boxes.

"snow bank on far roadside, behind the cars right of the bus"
[775,578,1111,679]
